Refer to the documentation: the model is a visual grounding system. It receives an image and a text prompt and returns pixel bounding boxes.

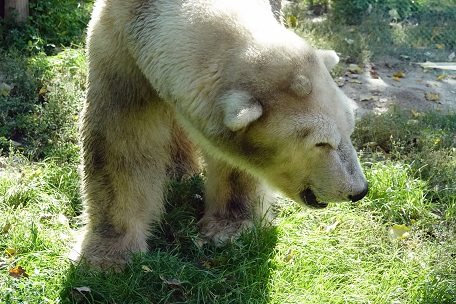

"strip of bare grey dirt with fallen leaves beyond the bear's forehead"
[336,60,456,115]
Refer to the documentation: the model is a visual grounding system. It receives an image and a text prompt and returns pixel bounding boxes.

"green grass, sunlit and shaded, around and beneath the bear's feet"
[0,152,456,303]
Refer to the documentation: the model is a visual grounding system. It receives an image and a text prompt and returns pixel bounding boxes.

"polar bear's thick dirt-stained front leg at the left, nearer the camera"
[79,101,171,269]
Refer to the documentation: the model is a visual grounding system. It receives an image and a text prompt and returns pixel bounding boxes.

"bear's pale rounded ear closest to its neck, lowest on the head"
[220,90,263,131]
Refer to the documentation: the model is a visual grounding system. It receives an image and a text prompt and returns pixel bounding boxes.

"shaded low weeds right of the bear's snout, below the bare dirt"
[353,109,456,204]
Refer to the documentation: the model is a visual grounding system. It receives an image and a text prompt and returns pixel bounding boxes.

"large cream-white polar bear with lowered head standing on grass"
[80,0,367,267]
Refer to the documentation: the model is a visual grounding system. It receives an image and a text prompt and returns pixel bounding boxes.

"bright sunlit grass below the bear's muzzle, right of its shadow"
[271,200,456,303]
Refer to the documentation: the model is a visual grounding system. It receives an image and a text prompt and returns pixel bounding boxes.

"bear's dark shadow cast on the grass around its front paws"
[57,177,277,303]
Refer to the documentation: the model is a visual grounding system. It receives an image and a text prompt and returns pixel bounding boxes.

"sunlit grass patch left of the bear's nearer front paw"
[0,156,78,303]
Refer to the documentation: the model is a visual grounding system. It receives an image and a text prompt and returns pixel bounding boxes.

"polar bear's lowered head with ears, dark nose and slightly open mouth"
[211,40,368,208]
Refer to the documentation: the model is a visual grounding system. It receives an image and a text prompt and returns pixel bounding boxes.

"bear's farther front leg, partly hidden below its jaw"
[199,155,274,244]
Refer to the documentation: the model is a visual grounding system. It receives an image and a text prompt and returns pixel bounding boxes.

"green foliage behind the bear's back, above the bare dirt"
[285,0,456,63]
